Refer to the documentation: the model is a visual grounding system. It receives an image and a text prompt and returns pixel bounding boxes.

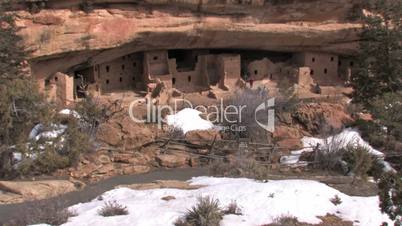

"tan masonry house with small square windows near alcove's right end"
[293,52,339,85]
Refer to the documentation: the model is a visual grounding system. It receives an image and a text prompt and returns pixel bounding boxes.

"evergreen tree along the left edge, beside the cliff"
[0,3,47,147]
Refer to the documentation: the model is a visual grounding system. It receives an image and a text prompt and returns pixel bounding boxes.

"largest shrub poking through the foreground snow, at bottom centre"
[175,196,223,226]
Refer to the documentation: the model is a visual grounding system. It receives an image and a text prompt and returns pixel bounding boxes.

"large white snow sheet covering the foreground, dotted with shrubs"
[64,177,391,226]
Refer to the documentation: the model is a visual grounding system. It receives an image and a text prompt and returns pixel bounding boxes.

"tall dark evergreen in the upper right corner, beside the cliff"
[352,0,402,105]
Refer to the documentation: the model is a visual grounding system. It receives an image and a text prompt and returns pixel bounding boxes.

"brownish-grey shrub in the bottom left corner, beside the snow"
[6,199,77,226]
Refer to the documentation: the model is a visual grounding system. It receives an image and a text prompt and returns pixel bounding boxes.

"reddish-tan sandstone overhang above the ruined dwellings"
[10,0,360,76]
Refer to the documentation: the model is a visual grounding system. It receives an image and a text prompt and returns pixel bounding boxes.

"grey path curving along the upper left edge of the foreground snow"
[0,168,208,222]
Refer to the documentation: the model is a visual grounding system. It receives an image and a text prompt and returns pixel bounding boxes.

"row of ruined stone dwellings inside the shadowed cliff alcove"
[38,49,353,104]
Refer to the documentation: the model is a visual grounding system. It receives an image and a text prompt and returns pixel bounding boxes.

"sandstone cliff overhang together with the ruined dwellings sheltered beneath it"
[13,0,358,104]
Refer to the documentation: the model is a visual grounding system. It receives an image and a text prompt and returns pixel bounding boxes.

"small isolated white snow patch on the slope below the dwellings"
[166,108,214,134]
